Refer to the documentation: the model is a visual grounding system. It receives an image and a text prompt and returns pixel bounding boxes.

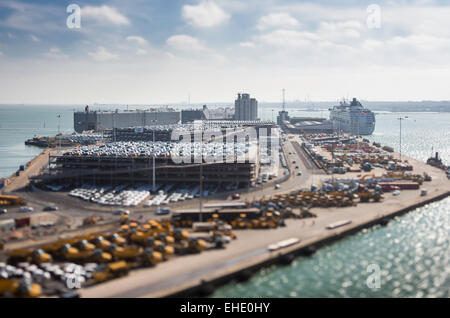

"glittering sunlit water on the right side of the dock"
[213,110,450,297]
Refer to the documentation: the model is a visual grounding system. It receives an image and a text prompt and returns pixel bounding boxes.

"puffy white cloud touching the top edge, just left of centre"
[182,1,230,28]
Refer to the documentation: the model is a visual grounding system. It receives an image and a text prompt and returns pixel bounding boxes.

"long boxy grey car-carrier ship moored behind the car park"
[73,106,181,133]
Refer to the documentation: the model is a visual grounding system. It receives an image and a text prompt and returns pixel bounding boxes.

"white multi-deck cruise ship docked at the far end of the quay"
[330,98,375,135]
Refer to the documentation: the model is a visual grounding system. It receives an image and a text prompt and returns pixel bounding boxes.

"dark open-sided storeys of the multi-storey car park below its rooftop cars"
[33,146,259,187]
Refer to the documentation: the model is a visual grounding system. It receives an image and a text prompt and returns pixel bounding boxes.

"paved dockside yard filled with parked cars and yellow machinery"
[0,112,450,297]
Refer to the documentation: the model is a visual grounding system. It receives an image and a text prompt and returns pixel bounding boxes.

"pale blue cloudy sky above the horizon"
[0,0,450,104]
